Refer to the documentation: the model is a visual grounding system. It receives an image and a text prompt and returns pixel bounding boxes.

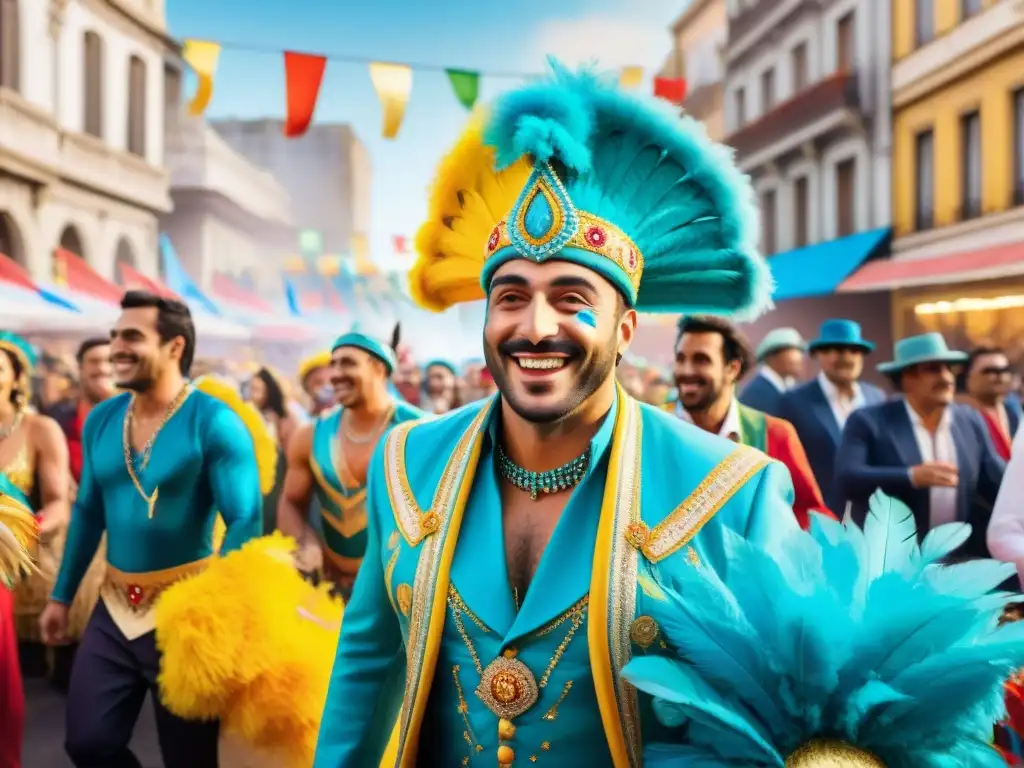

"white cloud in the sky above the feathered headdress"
[525,13,672,74]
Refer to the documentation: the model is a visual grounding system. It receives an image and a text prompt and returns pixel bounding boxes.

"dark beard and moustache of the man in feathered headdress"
[483,337,618,424]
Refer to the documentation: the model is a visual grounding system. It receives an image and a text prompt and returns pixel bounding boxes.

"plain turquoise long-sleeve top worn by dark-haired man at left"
[53,390,263,603]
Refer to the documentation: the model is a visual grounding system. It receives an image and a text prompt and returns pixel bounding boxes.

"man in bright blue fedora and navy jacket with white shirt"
[779,319,886,512]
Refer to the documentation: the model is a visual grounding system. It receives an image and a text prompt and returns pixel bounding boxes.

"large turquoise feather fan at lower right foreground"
[623,492,1024,768]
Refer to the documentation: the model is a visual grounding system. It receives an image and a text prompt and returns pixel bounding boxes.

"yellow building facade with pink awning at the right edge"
[854,0,1024,348]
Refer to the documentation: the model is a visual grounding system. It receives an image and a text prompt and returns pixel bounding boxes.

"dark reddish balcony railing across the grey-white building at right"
[727,72,861,159]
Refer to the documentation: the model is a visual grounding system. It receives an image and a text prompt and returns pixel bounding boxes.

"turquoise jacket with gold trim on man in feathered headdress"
[314,391,797,768]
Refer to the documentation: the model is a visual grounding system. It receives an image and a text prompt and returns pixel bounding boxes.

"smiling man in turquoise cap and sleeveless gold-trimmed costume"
[278,329,423,597]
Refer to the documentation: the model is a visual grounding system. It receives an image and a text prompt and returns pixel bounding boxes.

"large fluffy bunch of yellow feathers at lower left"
[156,534,344,768]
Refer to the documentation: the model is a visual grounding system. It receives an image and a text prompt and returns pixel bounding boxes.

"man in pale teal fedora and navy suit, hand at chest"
[836,333,1006,557]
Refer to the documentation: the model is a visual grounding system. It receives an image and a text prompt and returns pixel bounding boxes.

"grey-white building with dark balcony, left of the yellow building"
[724,0,892,255]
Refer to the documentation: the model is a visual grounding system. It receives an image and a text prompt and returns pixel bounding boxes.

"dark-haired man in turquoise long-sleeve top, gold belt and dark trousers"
[41,292,262,768]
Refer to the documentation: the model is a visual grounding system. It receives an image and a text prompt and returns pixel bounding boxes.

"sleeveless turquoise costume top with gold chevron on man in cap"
[309,400,423,571]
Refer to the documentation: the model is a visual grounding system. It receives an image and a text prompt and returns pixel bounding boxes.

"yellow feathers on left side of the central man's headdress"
[409,112,532,312]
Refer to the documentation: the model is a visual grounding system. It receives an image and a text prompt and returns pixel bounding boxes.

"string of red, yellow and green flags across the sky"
[182,39,686,139]
